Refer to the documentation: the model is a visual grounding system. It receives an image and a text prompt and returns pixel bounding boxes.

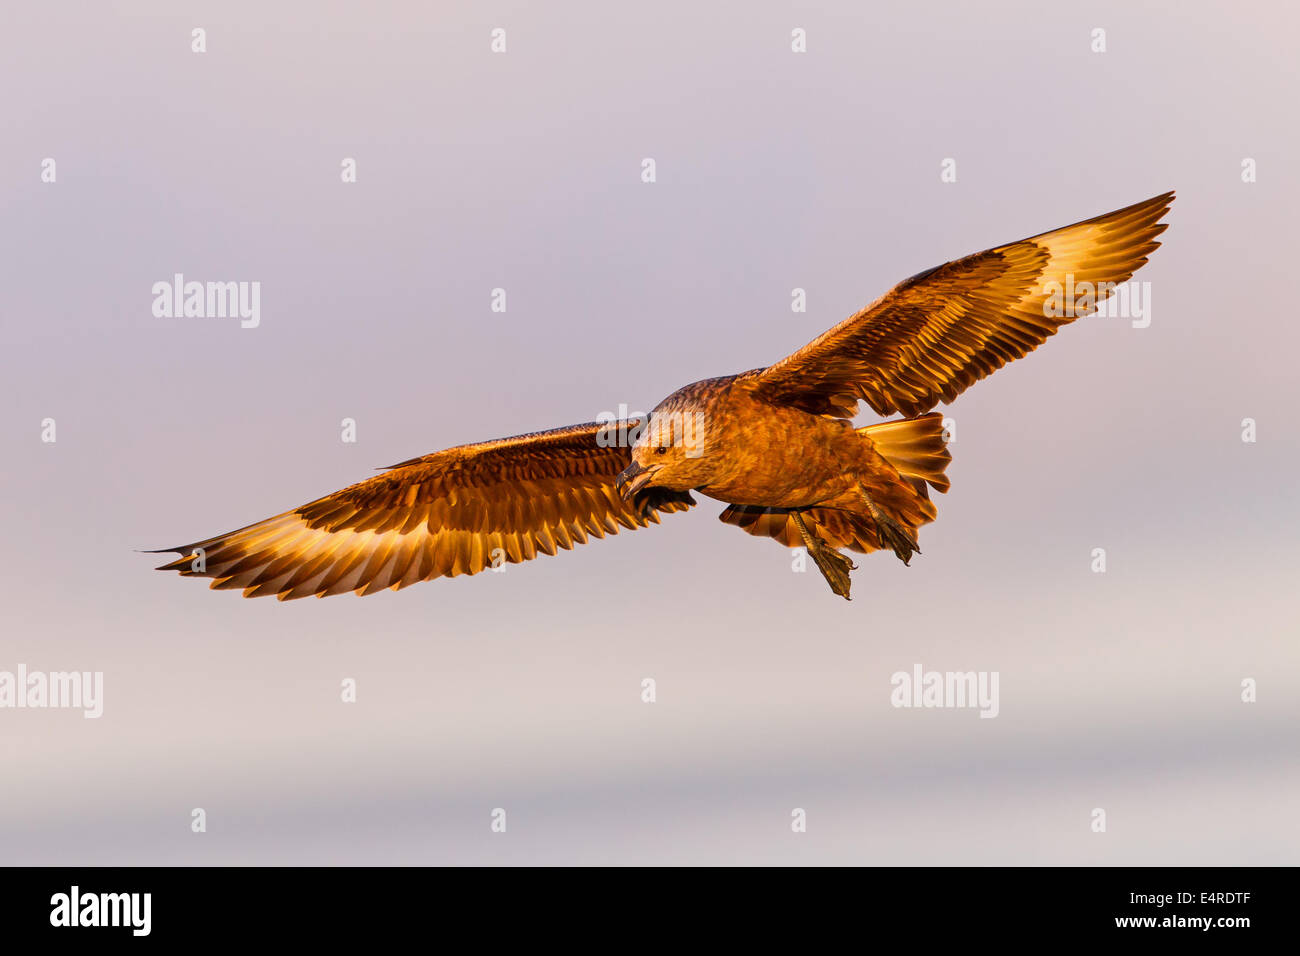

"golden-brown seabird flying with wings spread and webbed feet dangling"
[155,193,1174,601]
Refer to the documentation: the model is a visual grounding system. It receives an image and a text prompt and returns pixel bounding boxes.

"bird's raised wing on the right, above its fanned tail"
[745,193,1174,418]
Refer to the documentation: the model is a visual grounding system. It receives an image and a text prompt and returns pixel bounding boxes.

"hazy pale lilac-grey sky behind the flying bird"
[0,3,1300,864]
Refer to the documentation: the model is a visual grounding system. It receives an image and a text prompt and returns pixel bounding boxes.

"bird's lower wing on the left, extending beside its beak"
[150,421,694,601]
